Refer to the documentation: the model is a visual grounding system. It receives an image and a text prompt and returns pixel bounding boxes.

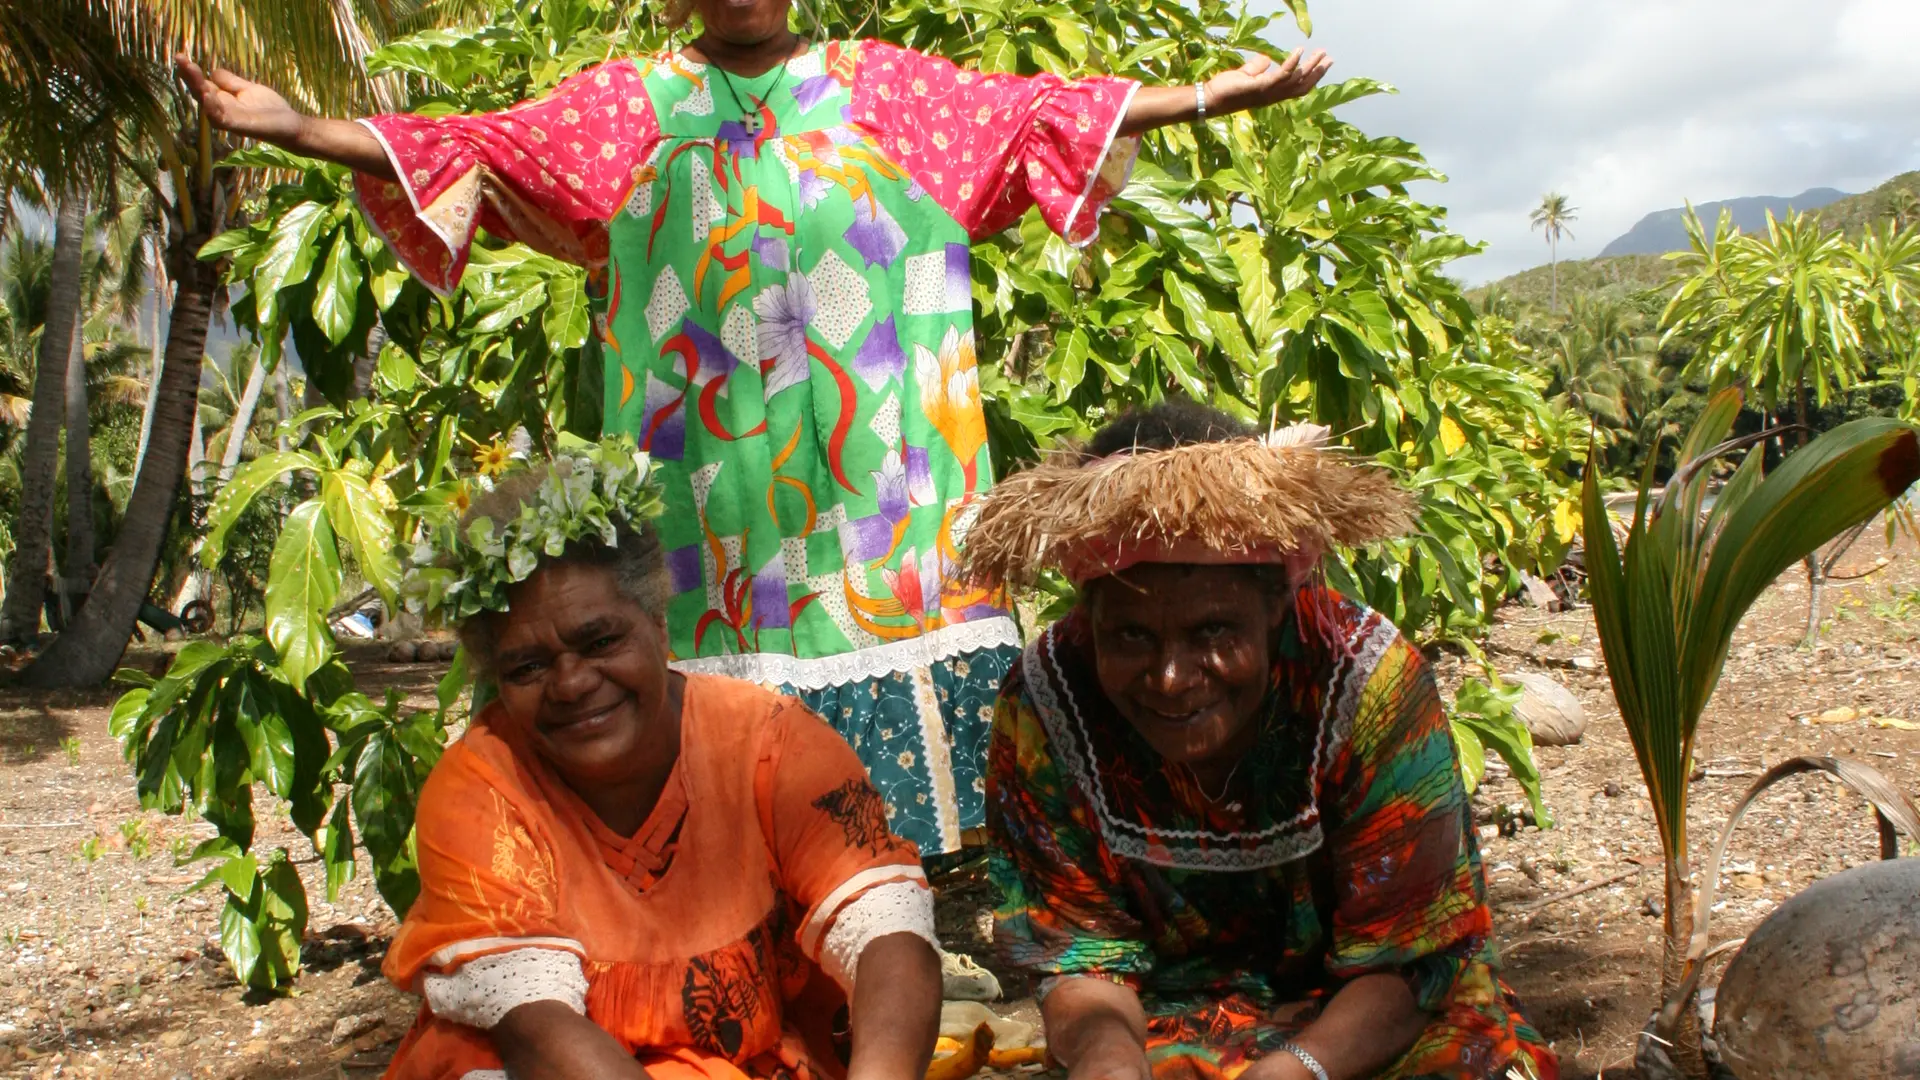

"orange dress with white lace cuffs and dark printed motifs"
[384,675,931,1080]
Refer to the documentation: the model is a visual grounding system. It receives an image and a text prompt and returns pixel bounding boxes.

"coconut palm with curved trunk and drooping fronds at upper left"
[0,0,439,686]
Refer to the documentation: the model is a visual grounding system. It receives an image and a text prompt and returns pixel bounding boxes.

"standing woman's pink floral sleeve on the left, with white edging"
[355,60,659,294]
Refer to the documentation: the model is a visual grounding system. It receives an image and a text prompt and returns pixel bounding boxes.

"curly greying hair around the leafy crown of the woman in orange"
[459,459,670,676]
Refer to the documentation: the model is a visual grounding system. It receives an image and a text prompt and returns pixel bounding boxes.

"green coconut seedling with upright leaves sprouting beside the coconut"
[1582,390,1920,1076]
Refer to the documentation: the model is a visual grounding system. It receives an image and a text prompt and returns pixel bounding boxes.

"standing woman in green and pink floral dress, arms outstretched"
[179,0,1329,855]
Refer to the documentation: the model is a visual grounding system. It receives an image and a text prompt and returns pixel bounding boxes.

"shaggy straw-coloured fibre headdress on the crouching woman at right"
[962,438,1413,586]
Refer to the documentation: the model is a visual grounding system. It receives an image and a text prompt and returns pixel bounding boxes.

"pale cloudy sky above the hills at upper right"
[1252,0,1920,282]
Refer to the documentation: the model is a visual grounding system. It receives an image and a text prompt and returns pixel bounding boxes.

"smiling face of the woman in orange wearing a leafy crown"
[492,563,680,790]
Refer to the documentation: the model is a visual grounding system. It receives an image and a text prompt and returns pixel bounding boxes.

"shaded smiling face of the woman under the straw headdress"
[1091,563,1290,765]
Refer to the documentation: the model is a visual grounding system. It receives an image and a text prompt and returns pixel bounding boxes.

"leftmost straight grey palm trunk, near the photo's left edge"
[0,194,86,644]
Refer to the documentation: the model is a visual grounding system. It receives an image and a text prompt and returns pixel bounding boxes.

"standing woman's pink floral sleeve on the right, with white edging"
[852,42,1139,244]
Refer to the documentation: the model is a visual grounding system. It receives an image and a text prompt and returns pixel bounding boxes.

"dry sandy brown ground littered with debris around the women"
[0,544,1920,1080]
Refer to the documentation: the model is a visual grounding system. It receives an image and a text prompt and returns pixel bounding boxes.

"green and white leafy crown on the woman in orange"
[401,436,662,623]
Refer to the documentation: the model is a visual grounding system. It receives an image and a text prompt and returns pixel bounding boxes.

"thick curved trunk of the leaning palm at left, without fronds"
[21,176,221,688]
